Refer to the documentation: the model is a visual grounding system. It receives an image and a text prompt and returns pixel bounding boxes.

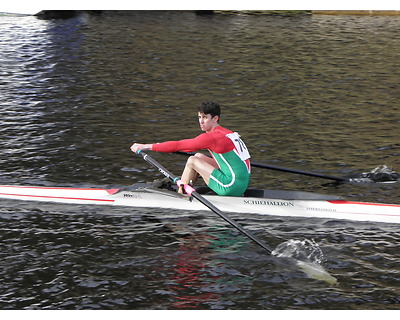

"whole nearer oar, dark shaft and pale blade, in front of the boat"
[137,150,337,285]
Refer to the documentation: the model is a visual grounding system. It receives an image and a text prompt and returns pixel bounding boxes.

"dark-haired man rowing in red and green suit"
[131,102,250,196]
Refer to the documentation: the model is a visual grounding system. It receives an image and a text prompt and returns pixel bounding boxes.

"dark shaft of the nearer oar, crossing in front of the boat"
[138,150,272,253]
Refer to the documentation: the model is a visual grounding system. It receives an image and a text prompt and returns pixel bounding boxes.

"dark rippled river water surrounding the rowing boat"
[0,11,400,310]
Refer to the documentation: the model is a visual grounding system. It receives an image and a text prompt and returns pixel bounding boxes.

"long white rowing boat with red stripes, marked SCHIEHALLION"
[0,183,400,223]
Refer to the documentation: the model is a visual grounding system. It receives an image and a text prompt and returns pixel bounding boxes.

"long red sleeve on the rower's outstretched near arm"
[153,133,214,152]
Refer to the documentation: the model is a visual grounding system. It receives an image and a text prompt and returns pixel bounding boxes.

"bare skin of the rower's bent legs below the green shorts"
[178,153,218,193]
